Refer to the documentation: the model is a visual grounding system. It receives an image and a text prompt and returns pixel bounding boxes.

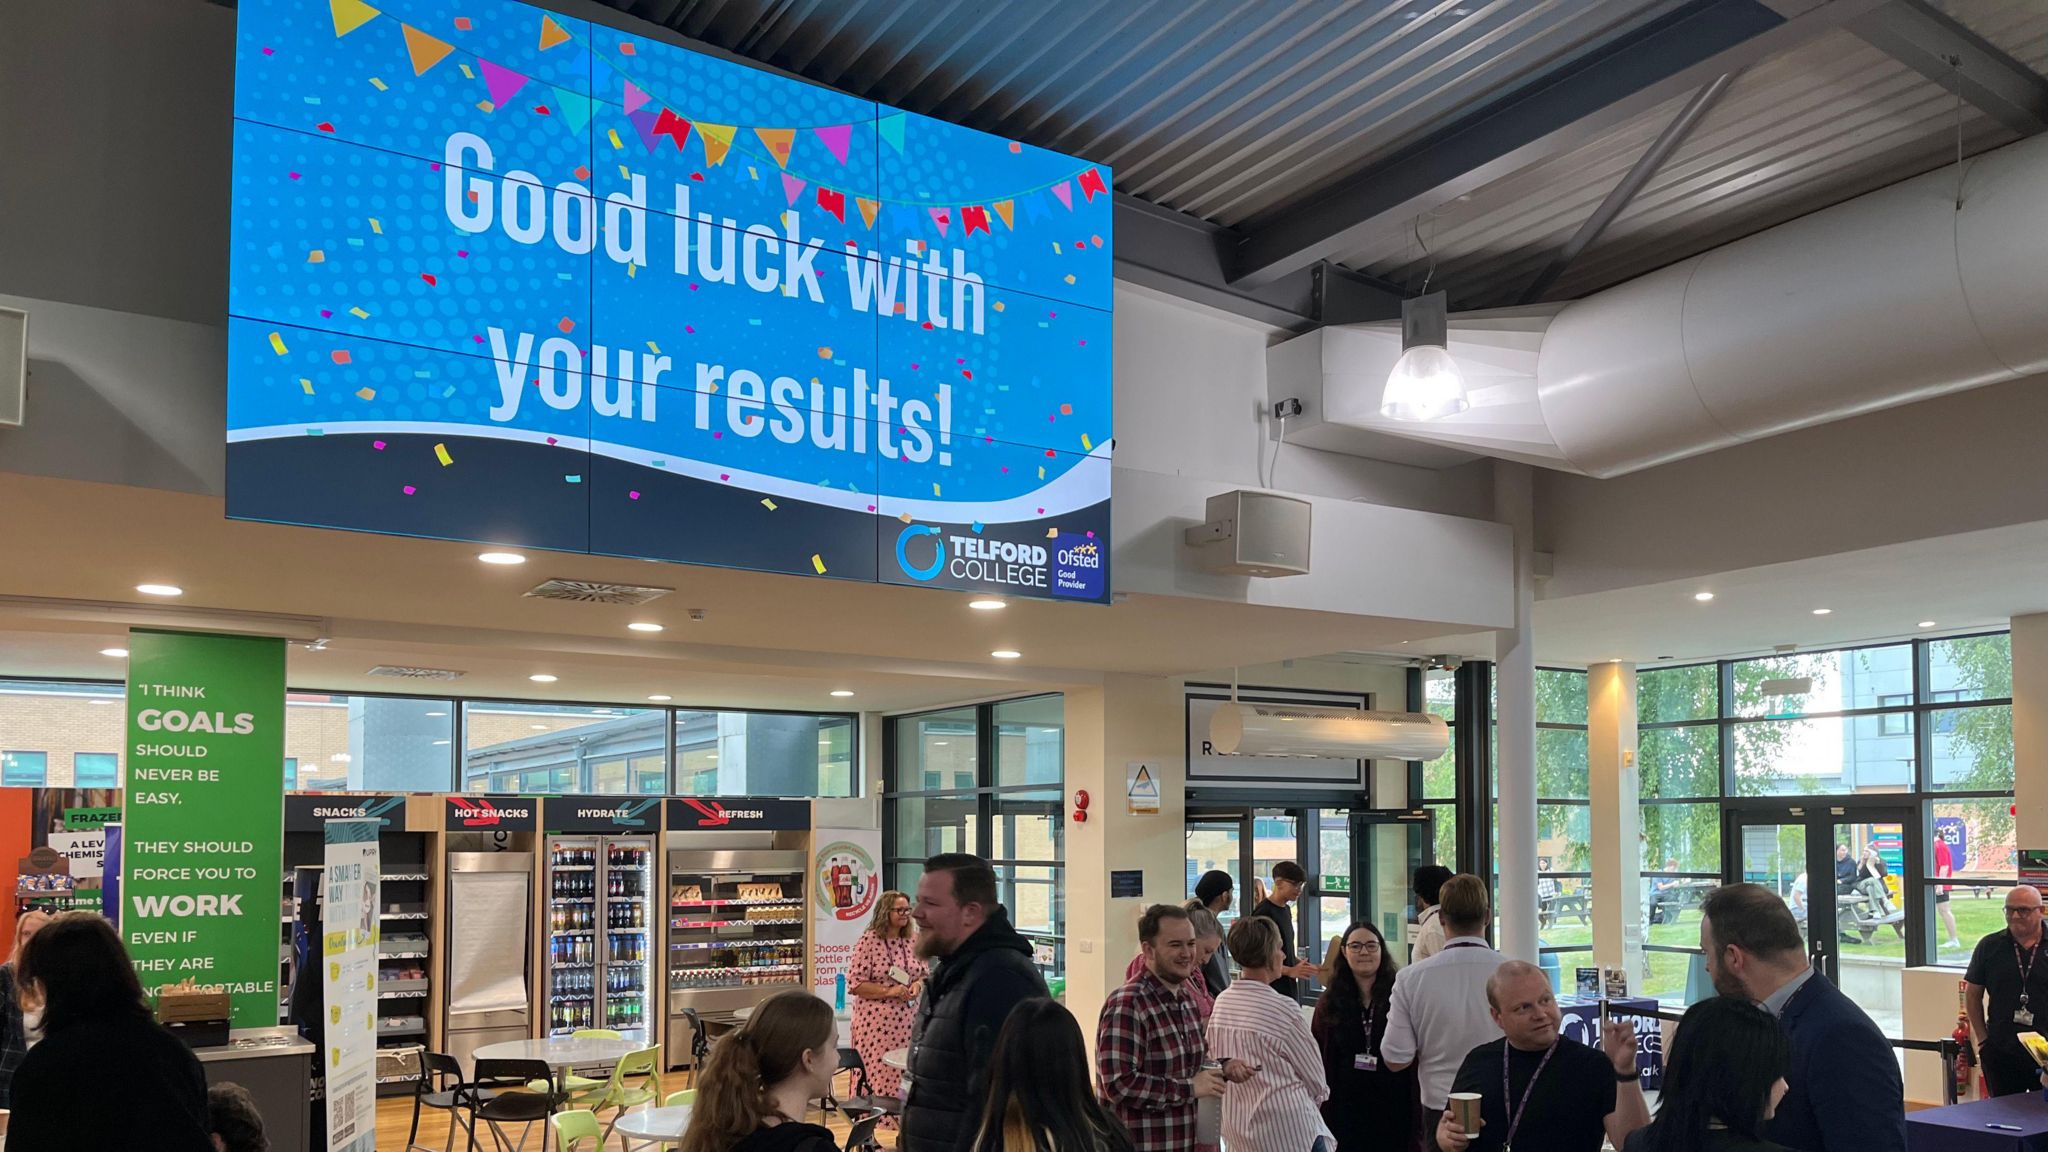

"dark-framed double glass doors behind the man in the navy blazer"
[1722,801,1919,1035]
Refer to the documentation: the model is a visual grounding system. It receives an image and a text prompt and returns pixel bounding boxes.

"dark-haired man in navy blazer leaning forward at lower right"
[1700,883,1907,1152]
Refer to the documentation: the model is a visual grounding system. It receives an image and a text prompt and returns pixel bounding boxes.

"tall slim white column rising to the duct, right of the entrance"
[1477,461,1536,963]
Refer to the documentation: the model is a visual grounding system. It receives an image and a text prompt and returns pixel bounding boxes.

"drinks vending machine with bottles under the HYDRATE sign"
[541,795,662,1041]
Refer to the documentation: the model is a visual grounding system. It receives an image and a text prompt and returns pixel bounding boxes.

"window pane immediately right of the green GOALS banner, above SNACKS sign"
[285,693,455,791]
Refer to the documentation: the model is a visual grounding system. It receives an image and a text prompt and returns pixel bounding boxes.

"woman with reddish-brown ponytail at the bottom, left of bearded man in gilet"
[682,992,840,1152]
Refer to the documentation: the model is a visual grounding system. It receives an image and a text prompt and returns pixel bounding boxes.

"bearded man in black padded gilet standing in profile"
[905,853,1047,1152]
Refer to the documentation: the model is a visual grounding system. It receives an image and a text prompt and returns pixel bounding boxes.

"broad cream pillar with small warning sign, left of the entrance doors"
[1065,674,1188,1052]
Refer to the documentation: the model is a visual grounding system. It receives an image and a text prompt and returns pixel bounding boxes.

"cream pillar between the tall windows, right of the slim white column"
[1585,664,1645,984]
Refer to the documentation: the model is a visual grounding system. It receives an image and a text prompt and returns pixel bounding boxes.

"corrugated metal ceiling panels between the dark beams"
[608,0,2048,307]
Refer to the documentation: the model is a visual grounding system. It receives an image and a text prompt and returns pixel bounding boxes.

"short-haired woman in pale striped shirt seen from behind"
[1208,916,1337,1152]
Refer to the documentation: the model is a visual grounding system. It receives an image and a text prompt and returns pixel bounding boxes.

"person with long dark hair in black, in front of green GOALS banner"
[8,912,213,1152]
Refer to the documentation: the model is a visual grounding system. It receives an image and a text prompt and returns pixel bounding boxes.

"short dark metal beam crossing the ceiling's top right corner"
[1849,0,2048,135]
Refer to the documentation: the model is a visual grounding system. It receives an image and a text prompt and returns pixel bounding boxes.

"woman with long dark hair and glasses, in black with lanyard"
[1309,920,1421,1152]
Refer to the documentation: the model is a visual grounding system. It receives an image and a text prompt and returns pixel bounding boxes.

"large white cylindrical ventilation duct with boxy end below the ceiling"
[1266,133,2048,476]
